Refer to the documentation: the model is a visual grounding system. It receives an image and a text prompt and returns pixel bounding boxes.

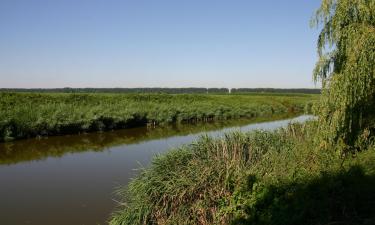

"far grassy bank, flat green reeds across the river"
[0,93,317,141]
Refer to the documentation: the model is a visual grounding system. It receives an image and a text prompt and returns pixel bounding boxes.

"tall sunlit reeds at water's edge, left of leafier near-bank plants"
[110,131,296,224]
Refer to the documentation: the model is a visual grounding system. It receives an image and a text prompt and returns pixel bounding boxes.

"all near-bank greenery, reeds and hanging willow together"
[110,0,375,225]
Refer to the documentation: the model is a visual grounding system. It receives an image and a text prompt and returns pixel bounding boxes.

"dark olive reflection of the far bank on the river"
[0,114,296,165]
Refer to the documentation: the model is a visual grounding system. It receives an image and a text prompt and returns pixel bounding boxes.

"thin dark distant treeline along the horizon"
[0,87,320,94]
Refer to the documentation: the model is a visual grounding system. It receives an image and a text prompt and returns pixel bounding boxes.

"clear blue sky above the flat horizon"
[0,0,320,88]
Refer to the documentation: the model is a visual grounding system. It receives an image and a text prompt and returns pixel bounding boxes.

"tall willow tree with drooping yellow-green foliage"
[313,0,375,153]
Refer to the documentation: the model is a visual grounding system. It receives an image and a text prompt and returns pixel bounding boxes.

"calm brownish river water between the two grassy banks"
[0,116,311,225]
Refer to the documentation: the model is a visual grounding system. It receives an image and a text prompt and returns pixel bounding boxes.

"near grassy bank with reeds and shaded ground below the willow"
[110,122,375,225]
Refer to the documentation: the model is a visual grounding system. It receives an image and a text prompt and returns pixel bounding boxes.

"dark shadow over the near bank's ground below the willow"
[233,166,375,225]
